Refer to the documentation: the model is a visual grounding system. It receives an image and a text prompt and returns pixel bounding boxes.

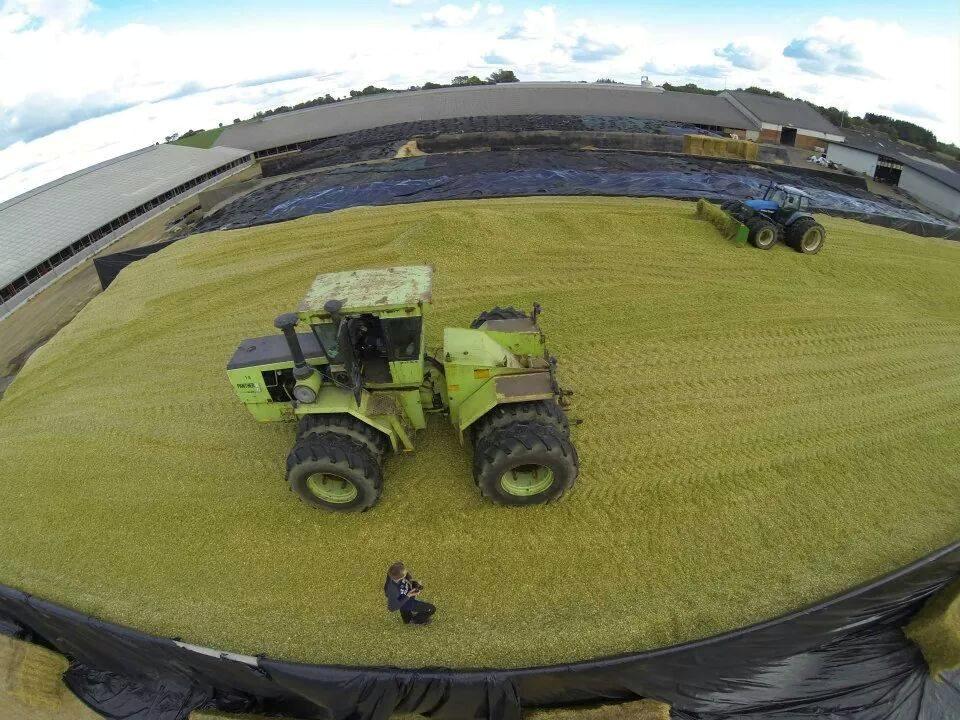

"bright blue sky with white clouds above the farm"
[0,0,960,201]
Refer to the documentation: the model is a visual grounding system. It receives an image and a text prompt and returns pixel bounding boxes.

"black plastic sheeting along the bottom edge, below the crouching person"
[0,543,960,720]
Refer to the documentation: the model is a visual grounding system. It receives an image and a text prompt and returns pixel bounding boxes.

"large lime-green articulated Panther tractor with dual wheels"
[227,266,579,512]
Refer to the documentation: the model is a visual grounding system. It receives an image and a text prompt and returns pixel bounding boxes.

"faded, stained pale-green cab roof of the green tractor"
[299,265,433,315]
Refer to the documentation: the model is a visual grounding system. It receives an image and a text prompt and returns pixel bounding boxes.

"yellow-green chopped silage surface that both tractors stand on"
[0,198,960,666]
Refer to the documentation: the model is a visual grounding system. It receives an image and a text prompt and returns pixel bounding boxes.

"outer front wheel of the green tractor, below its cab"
[287,432,383,512]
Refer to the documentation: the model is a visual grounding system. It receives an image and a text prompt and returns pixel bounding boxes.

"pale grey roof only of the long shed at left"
[0,145,249,286]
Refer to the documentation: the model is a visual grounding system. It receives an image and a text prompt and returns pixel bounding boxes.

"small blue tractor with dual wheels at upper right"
[720,183,827,255]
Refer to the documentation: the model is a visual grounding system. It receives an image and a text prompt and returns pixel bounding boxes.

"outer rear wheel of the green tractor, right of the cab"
[473,423,580,505]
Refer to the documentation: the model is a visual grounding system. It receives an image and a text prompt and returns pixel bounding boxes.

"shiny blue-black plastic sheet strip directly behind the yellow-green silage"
[196,150,960,239]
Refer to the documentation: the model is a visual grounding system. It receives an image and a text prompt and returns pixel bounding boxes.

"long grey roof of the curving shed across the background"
[217,82,758,150]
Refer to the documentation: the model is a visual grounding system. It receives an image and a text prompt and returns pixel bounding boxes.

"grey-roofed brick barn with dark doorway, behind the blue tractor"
[720,90,844,150]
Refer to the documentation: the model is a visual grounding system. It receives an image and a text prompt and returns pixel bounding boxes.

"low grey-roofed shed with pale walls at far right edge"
[827,130,960,220]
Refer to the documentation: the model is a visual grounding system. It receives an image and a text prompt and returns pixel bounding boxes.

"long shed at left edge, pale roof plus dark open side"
[0,145,251,318]
